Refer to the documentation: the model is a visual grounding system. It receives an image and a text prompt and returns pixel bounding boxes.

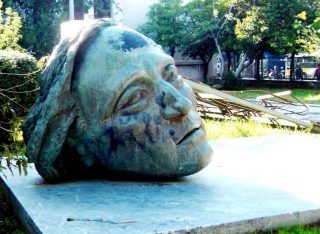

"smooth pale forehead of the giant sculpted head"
[74,26,174,90]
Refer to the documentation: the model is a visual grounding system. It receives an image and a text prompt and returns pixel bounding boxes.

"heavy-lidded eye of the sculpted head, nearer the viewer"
[115,83,150,115]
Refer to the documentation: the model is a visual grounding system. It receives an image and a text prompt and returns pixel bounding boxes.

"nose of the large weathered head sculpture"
[161,82,192,120]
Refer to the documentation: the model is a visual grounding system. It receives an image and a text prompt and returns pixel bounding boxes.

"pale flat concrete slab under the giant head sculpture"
[2,136,320,234]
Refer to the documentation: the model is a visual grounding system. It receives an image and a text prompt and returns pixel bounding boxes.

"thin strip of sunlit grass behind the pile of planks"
[231,88,320,104]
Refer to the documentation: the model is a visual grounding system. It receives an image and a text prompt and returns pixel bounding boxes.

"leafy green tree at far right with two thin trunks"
[235,0,320,80]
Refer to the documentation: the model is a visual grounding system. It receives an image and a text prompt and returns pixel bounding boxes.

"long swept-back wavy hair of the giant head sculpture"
[22,21,112,181]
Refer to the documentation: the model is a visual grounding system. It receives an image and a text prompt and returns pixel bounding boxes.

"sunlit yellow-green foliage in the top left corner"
[0,0,23,51]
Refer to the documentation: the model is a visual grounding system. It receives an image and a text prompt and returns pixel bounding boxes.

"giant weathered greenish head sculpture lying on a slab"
[23,20,211,182]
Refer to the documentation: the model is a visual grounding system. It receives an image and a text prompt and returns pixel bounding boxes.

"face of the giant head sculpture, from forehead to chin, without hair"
[72,26,212,177]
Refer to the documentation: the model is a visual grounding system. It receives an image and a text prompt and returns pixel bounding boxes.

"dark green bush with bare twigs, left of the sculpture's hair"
[0,51,41,151]
